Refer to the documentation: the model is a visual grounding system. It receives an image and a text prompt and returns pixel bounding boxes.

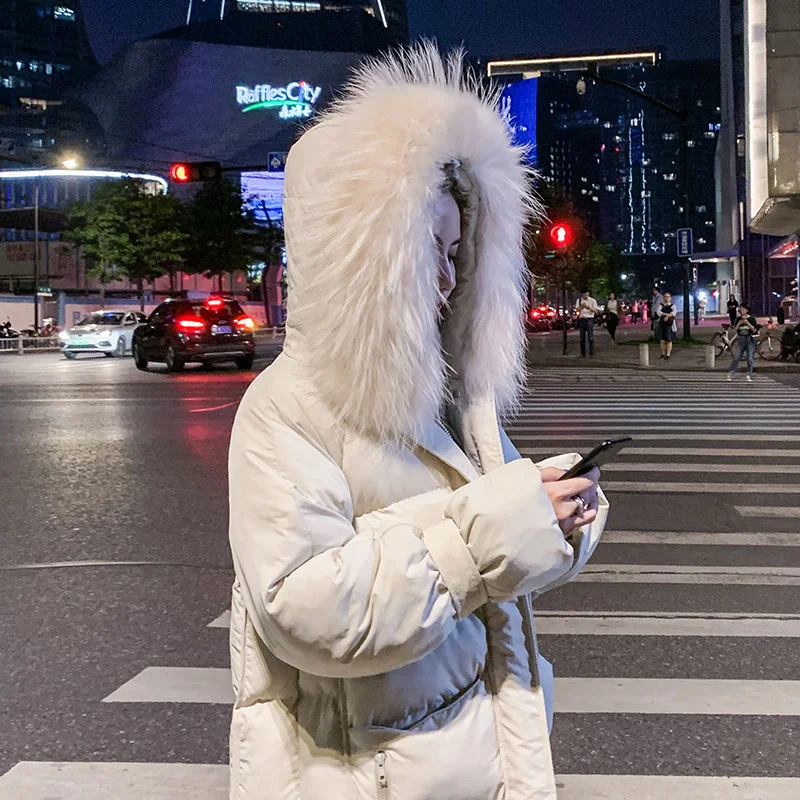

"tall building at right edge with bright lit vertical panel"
[717,0,800,316]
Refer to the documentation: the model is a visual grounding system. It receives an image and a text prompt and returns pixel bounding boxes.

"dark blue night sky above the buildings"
[83,0,719,62]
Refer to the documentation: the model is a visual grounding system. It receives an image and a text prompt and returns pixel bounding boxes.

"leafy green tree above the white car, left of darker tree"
[66,179,187,310]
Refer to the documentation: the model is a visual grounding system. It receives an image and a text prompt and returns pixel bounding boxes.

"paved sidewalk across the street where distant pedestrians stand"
[527,316,800,373]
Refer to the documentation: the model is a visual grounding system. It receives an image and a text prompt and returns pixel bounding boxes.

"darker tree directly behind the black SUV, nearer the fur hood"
[185,179,262,290]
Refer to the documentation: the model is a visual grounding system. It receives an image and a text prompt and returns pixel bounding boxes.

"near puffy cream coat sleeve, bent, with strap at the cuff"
[229,409,573,677]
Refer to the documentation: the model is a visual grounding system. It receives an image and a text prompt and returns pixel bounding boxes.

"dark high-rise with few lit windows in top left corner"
[0,0,97,165]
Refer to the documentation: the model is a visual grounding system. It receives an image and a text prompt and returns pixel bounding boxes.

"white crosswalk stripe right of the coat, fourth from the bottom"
[574,564,800,586]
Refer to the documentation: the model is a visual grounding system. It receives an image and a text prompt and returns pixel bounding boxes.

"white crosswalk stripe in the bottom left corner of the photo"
[0,761,230,800]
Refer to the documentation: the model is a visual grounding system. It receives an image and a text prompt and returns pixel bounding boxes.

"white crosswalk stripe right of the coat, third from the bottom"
[536,611,800,639]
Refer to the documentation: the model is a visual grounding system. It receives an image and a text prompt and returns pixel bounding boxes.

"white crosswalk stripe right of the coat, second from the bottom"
[555,678,800,717]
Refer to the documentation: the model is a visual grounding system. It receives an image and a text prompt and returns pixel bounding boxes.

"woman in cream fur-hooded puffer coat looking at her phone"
[229,44,607,800]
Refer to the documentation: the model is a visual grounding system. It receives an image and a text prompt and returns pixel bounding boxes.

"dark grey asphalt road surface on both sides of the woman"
[0,347,800,800]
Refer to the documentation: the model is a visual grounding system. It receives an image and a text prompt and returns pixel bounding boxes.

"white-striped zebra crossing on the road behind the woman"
[0,369,800,800]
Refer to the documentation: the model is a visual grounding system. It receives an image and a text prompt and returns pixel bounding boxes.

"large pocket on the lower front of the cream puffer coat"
[349,679,503,800]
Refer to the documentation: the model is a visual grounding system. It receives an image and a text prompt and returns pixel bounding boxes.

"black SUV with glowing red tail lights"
[132,297,255,372]
